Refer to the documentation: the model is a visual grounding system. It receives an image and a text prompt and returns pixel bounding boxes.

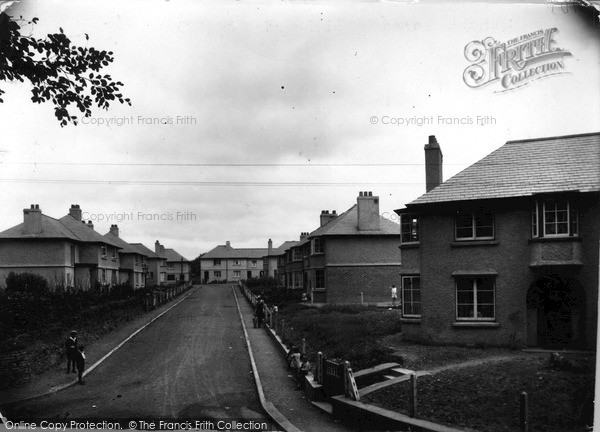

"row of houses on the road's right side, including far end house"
[201,133,600,347]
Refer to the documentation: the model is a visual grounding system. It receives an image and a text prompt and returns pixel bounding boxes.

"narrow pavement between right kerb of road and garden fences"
[235,289,355,432]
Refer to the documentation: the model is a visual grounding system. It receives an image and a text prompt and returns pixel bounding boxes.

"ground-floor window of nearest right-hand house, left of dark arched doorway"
[456,276,495,321]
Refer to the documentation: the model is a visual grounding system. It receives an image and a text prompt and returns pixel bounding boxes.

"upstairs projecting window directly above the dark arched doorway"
[531,198,579,237]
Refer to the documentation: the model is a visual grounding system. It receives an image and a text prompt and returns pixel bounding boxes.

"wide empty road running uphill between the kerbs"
[2,285,273,425]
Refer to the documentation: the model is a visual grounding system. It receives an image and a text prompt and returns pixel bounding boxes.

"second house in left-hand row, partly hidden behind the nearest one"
[104,225,148,289]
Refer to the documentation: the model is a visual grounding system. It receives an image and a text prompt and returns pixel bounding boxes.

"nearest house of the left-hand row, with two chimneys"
[0,204,120,289]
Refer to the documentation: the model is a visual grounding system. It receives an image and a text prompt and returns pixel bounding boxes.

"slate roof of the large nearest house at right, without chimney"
[407,132,600,206]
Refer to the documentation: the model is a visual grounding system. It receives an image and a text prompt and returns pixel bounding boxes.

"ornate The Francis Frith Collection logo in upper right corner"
[463,27,571,93]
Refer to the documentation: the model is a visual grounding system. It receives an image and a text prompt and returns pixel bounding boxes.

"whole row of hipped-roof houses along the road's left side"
[0,204,190,289]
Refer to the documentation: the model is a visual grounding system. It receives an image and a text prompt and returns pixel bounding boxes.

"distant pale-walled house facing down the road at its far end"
[200,241,268,283]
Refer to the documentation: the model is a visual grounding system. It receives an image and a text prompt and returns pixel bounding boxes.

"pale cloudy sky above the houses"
[0,0,600,259]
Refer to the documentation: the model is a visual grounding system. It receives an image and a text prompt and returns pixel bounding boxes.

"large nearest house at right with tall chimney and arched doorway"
[396,133,600,349]
